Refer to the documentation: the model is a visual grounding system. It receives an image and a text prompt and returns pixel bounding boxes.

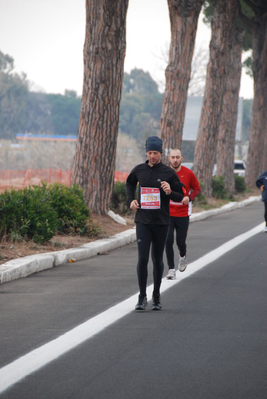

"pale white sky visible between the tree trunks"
[0,0,253,98]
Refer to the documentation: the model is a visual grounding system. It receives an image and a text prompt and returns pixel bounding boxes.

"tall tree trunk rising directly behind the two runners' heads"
[159,0,204,161]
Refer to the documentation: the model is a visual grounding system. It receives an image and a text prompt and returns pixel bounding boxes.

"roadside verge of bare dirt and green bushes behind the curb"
[0,176,259,265]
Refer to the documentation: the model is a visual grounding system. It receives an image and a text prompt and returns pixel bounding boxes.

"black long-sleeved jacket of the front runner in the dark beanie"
[126,161,184,225]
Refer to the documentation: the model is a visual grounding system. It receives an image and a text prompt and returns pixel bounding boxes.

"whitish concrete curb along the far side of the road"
[0,196,261,284]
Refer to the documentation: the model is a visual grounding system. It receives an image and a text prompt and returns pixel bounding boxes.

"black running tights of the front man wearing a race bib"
[136,223,169,295]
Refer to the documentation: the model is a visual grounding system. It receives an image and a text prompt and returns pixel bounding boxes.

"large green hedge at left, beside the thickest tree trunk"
[0,184,99,243]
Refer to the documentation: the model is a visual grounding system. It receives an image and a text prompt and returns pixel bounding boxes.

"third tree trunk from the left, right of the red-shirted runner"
[194,0,239,196]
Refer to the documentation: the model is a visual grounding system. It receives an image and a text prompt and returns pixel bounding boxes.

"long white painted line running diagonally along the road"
[0,223,264,393]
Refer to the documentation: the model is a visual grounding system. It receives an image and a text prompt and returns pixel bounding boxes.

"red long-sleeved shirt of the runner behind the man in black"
[170,165,201,217]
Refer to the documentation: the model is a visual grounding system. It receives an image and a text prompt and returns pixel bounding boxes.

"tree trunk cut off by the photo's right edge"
[245,11,267,187]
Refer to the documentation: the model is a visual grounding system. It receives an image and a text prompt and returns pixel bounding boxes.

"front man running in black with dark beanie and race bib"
[126,136,183,310]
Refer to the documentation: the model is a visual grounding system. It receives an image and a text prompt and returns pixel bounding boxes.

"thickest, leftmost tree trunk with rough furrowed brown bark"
[72,0,128,214]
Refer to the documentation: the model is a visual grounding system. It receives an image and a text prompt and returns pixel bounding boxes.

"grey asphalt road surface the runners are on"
[0,202,267,399]
